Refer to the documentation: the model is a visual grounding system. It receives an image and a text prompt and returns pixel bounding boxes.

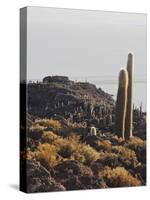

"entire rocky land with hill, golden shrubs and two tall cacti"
[21,54,146,192]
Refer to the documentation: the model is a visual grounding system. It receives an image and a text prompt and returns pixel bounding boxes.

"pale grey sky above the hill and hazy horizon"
[27,7,146,80]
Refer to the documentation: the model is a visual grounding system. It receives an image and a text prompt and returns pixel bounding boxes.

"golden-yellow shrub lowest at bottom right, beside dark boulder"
[103,167,141,187]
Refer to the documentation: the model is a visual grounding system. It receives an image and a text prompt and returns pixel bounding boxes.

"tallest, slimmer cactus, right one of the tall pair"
[125,53,133,138]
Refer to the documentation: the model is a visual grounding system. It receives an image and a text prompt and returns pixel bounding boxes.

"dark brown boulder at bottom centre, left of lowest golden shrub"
[55,160,107,190]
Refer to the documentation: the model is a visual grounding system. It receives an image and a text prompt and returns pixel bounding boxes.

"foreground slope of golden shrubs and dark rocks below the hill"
[21,115,146,192]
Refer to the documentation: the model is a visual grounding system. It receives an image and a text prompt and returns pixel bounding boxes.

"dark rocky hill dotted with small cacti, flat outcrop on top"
[27,76,115,129]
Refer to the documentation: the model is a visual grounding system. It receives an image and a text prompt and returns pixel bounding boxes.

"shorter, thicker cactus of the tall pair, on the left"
[116,69,128,139]
